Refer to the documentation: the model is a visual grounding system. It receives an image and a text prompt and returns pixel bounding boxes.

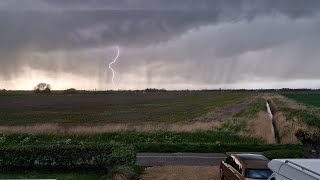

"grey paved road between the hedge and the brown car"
[137,153,226,166]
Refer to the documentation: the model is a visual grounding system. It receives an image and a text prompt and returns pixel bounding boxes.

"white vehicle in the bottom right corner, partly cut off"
[268,159,320,180]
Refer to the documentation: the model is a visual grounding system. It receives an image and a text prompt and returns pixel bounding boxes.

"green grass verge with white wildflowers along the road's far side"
[0,131,264,147]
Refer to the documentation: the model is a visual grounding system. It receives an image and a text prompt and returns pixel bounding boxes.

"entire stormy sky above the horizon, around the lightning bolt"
[0,0,320,90]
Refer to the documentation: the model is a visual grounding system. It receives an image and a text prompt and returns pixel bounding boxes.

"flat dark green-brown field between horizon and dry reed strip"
[0,92,251,126]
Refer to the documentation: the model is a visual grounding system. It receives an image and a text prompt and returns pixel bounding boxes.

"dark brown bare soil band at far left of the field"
[0,95,170,112]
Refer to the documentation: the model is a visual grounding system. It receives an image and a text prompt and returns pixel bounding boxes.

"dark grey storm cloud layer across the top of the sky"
[0,0,320,50]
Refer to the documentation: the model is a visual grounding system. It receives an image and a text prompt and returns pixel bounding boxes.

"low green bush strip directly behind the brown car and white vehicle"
[263,150,303,159]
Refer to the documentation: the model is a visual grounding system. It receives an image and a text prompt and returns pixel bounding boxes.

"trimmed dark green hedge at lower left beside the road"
[0,145,136,170]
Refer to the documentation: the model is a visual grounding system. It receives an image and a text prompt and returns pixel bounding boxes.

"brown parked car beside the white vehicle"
[220,154,272,180]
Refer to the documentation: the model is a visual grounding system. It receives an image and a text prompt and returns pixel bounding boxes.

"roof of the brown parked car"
[233,154,270,169]
